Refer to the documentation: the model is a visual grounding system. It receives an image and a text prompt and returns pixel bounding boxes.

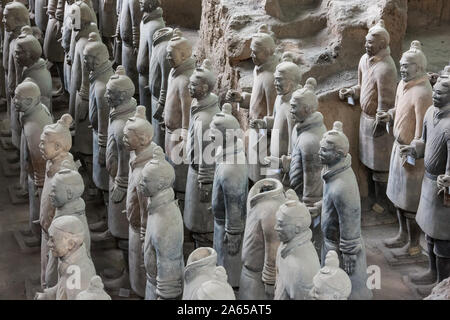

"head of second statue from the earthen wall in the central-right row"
[274,52,302,96]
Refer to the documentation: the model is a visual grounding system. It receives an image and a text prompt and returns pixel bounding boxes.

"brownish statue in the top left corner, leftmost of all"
[3,1,30,150]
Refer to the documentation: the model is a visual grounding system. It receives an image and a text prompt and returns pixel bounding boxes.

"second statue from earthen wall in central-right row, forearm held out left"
[250,52,302,185]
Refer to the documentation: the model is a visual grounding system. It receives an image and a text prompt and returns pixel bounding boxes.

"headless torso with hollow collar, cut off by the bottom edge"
[183,247,235,300]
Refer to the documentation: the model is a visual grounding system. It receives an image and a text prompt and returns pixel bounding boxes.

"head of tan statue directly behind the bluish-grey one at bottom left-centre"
[123,106,153,152]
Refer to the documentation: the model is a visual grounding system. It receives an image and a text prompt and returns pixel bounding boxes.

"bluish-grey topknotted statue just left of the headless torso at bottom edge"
[140,146,184,300]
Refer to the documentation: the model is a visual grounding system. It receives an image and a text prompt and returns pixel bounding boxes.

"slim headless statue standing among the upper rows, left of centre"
[147,28,173,150]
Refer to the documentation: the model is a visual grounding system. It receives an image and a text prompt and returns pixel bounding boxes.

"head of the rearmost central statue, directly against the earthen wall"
[250,24,276,66]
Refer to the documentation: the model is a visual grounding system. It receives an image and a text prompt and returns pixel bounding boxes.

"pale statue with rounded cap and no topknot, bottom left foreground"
[35,216,96,300]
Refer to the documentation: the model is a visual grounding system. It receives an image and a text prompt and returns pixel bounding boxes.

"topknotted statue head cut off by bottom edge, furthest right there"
[309,250,352,300]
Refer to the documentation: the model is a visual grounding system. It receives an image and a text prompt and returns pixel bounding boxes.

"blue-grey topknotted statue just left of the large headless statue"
[210,103,248,288]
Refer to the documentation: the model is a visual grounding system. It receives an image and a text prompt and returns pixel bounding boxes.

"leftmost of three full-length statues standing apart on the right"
[339,20,397,210]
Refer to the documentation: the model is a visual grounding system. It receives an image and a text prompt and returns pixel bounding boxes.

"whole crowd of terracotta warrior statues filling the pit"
[3,0,450,299]
